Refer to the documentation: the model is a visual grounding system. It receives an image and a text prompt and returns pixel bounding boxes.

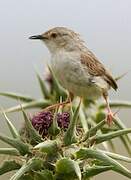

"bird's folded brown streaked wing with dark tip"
[81,51,118,90]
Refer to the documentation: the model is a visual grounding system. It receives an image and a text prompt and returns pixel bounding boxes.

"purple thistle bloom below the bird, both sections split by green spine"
[31,111,70,138]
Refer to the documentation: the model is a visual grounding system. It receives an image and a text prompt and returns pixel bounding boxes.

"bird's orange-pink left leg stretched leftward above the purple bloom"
[42,92,74,111]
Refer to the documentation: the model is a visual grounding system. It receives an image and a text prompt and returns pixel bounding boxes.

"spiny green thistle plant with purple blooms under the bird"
[0,69,131,180]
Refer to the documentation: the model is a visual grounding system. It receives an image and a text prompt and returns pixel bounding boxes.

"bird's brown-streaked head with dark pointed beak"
[29,27,82,53]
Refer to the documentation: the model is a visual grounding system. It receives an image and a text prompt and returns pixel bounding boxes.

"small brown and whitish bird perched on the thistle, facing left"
[29,27,118,125]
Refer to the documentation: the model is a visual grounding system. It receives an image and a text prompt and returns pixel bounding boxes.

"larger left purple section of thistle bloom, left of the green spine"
[31,111,53,137]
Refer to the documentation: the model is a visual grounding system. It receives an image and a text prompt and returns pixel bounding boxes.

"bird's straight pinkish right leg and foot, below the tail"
[103,93,114,126]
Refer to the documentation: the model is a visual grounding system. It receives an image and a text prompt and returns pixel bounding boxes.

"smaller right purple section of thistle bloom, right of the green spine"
[57,112,70,130]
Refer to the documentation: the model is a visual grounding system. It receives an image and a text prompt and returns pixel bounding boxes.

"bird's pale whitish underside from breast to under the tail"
[51,51,109,99]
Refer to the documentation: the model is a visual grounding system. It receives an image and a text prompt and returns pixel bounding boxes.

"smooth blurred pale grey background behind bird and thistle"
[0,0,131,180]
